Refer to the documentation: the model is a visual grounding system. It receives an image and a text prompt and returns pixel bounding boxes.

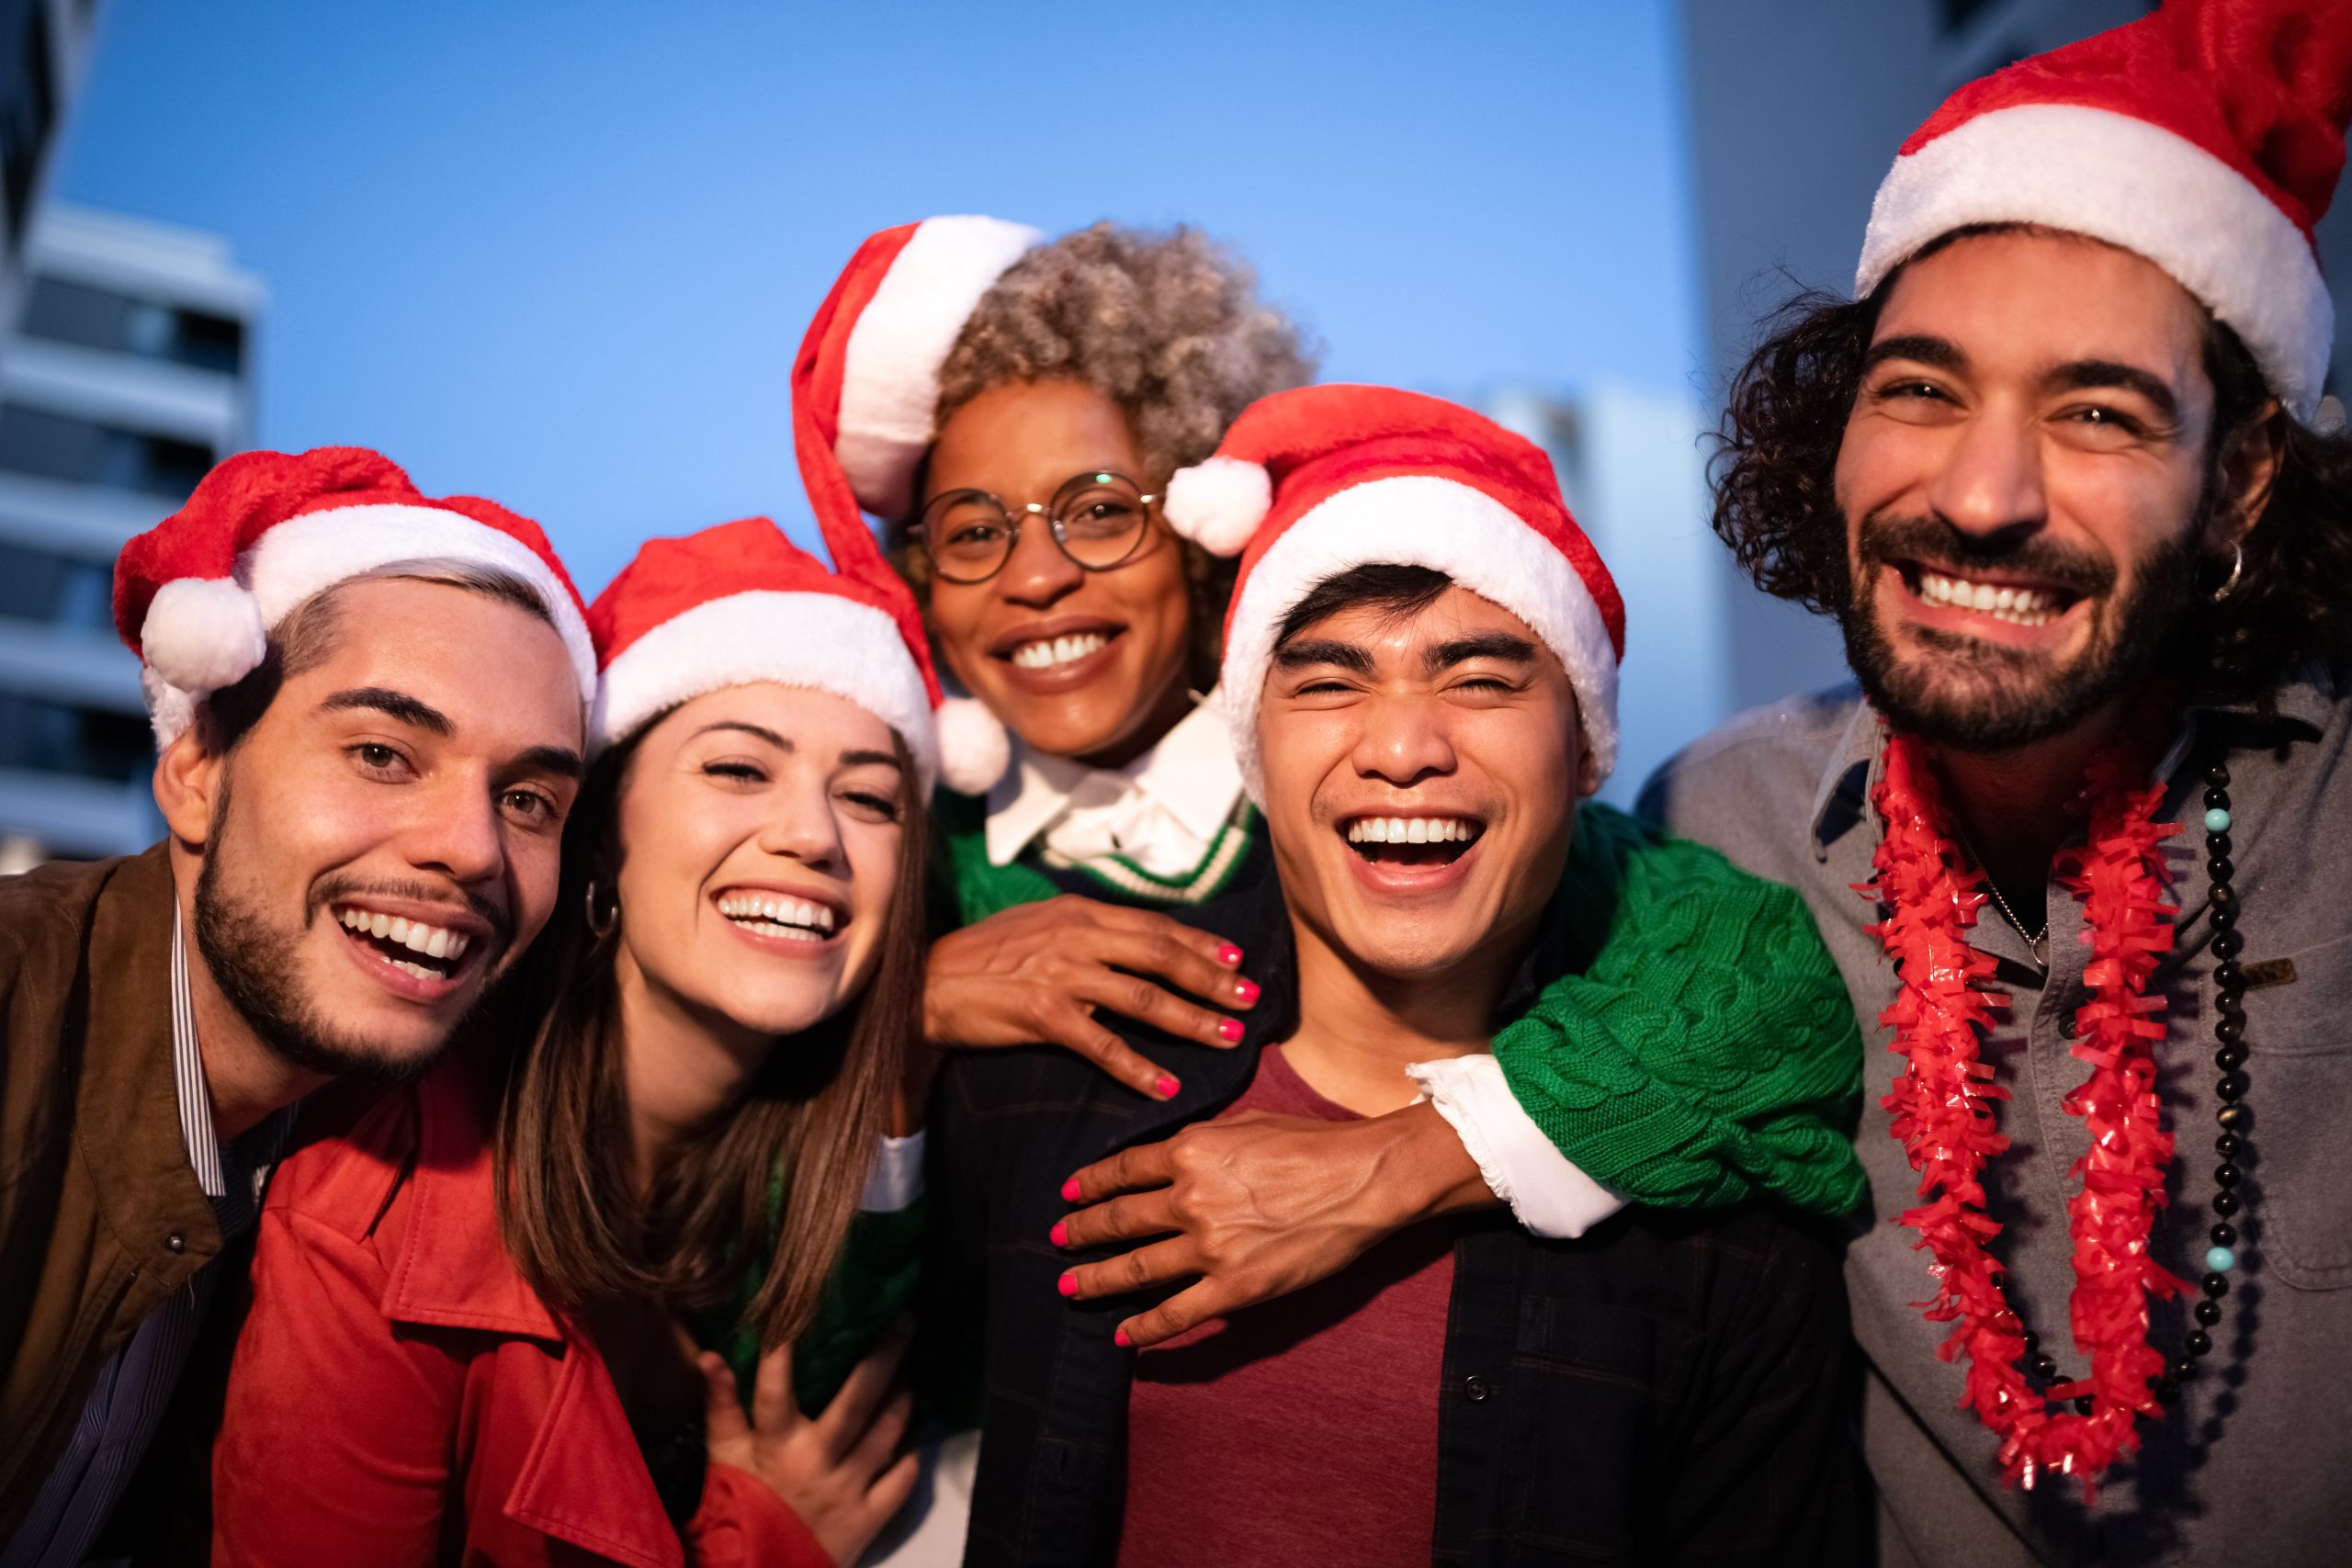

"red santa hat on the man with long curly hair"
[1853,0,2352,419]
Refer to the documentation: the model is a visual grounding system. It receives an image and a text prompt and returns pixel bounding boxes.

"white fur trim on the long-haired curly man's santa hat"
[1853,104,2335,421]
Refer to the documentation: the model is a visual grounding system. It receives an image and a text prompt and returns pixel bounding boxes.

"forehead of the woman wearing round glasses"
[929,381,1143,501]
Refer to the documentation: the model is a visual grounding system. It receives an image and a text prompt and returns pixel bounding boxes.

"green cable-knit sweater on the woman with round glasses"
[933,792,1863,1215]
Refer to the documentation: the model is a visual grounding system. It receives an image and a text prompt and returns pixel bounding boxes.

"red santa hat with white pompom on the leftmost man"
[115,446,595,745]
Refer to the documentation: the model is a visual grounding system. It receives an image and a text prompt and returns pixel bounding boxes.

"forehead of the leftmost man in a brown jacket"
[290,579,585,750]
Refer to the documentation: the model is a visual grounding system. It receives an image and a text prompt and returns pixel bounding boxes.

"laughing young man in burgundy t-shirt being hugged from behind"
[933,386,1856,1568]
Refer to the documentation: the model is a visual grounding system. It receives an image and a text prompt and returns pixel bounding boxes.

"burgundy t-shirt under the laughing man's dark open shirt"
[1120,1046,1456,1568]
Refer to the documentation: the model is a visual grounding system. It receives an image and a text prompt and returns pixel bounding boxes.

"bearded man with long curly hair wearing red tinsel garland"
[1644,0,2352,1568]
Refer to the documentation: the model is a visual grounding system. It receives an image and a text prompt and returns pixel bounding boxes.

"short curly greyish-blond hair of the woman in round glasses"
[894,221,1317,689]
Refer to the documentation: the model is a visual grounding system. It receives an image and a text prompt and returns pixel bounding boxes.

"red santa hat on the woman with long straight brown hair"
[588,517,938,792]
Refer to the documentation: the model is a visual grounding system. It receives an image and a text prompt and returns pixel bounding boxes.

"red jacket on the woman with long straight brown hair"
[211,1069,832,1568]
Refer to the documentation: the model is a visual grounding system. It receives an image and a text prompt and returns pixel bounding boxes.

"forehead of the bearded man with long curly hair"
[1872,231,2206,381]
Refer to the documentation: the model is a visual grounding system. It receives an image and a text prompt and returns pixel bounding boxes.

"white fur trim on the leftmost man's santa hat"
[141,503,595,745]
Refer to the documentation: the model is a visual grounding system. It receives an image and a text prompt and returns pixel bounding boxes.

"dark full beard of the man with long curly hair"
[1837,505,2206,752]
